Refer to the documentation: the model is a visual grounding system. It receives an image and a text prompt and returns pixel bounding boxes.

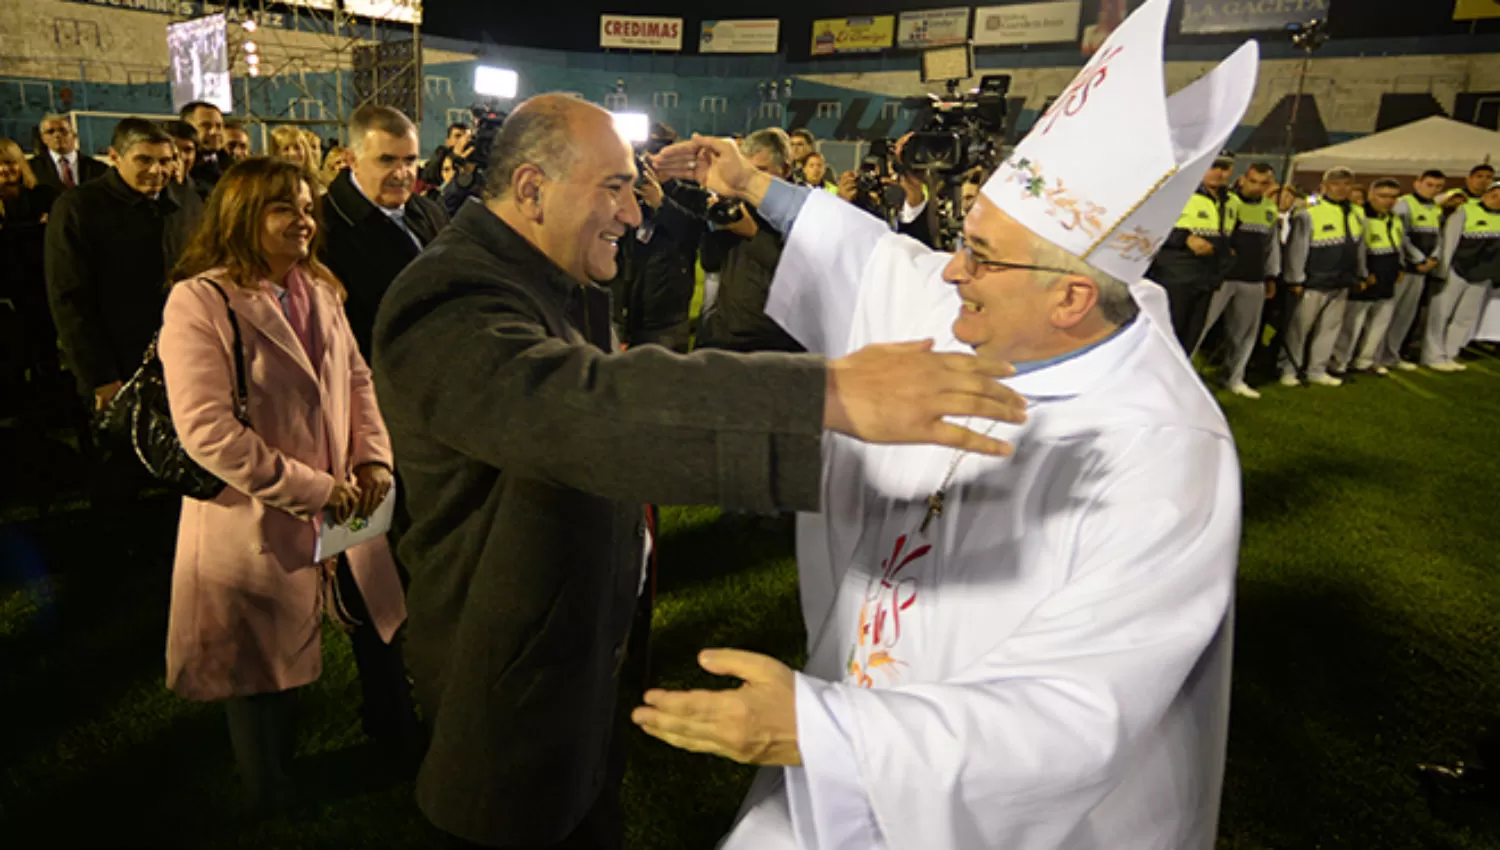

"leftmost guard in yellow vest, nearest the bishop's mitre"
[1146,154,1235,354]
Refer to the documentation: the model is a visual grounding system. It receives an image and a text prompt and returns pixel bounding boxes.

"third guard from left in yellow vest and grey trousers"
[1281,168,1368,387]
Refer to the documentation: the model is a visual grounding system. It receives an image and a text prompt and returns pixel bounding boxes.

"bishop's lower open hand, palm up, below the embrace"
[630,649,803,766]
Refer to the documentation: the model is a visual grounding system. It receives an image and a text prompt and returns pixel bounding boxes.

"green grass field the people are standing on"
[0,358,1500,850]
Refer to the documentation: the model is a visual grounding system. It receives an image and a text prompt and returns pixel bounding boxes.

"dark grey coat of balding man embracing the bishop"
[374,204,827,846]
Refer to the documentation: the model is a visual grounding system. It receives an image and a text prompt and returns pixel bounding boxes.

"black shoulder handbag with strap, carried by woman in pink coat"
[96,277,251,501]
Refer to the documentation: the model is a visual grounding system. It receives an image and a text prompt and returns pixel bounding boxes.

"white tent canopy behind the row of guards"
[1293,115,1500,177]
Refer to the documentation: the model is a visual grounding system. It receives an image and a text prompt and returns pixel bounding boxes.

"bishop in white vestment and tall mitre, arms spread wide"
[636,0,1257,850]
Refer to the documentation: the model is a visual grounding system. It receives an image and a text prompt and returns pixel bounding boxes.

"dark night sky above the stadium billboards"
[423,0,1500,60]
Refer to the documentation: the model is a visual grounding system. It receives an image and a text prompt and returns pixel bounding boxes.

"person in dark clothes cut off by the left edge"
[0,138,60,412]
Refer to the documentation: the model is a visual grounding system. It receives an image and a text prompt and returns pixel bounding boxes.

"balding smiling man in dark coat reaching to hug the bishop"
[374,94,1019,849]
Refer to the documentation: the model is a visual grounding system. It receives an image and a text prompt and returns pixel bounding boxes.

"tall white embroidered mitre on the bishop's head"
[984,0,1260,282]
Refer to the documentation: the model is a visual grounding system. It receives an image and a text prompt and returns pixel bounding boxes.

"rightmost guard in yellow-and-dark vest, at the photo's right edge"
[1422,183,1500,372]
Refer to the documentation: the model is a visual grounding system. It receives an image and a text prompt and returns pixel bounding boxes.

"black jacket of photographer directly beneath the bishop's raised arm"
[698,207,804,352]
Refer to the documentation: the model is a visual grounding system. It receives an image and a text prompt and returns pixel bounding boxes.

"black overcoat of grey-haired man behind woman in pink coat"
[323,169,449,360]
